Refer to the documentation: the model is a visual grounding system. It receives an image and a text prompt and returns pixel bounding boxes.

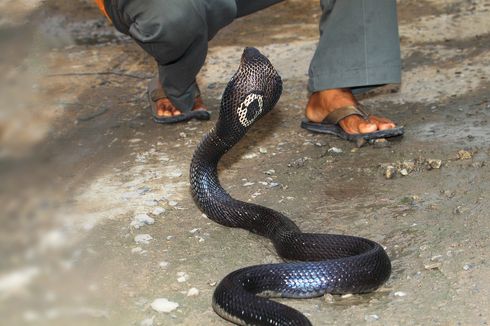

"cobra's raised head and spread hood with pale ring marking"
[218,48,282,134]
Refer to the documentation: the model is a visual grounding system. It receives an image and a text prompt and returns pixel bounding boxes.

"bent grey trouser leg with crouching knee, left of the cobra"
[113,0,237,111]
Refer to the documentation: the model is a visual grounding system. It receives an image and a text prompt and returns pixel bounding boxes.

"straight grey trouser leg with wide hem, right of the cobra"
[308,0,401,92]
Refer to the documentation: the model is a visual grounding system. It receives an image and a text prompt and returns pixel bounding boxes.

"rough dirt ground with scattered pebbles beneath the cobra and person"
[0,0,490,326]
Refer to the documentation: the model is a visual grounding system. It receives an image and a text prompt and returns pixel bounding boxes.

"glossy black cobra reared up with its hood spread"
[190,48,391,325]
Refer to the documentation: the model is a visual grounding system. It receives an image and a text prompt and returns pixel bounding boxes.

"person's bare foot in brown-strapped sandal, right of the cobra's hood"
[306,89,396,134]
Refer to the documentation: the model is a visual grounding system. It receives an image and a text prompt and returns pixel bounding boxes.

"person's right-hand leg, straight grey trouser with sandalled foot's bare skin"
[306,0,400,138]
